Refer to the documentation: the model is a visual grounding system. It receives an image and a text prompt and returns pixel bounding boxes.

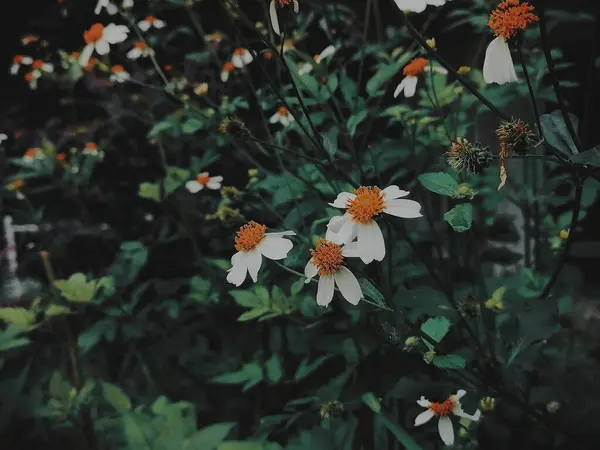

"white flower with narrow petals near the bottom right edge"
[415,389,481,445]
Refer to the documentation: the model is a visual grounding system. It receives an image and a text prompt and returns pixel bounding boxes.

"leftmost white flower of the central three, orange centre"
[227,221,296,286]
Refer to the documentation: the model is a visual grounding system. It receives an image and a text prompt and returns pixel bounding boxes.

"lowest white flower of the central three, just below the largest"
[304,239,363,306]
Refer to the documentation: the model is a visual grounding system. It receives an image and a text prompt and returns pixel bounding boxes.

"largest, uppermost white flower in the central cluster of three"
[325,185,422,264]
